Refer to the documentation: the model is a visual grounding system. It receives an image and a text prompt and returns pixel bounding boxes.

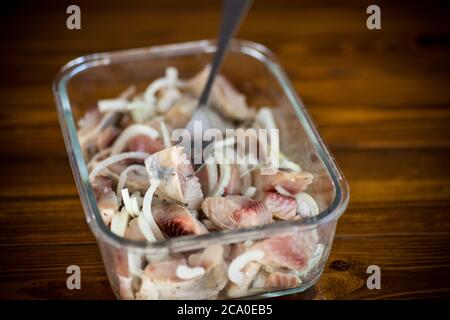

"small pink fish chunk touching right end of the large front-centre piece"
[261,192,297,220]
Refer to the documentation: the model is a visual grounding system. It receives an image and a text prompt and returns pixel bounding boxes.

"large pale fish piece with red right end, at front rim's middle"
[201,195,272,229]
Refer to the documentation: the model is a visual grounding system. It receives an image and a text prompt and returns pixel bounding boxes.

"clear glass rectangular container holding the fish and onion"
[53,40,349,299]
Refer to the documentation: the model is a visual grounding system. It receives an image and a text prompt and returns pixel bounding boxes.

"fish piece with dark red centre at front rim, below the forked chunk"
[152,204,208,237]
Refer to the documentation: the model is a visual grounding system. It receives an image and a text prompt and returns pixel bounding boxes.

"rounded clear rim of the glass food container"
[53,39,350,253]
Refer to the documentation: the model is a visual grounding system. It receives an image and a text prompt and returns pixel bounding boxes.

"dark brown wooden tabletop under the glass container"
[0,0,450,299]
